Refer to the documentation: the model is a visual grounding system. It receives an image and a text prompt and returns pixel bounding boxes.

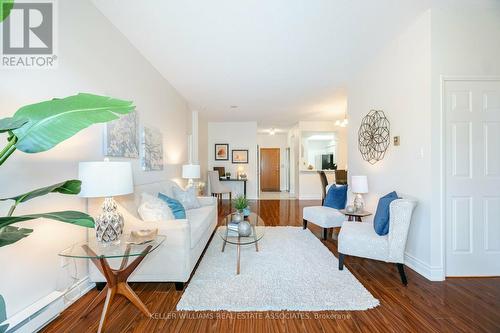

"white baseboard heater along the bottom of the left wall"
[4,276,95,333]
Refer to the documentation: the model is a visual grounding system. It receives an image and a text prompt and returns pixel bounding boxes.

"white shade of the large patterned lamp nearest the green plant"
[78,161,134,198]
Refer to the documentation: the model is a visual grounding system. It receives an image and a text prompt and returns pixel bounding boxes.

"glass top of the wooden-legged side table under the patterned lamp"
[59,235,167,259]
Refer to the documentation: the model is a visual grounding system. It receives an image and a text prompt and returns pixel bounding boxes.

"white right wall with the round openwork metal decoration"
[348,11,432,269]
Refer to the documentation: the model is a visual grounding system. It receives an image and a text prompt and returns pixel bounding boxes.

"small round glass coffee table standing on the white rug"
[217,212,265,274]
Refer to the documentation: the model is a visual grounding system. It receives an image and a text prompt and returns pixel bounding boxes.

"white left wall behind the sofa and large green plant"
[0,0,188,317]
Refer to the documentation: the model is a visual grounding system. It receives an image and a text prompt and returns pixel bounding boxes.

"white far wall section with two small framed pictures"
[207,121,257,199]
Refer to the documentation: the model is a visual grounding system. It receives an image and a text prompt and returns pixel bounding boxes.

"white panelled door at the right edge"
[444,80,500,276]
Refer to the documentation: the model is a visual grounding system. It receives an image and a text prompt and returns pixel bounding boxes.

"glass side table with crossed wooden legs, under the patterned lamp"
[59,235,166,332]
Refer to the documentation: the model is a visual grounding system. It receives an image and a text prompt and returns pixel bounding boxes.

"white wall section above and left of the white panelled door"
[430,0,500,272]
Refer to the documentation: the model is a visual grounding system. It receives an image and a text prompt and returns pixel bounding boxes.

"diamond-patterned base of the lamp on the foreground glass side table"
[95,198,123,244]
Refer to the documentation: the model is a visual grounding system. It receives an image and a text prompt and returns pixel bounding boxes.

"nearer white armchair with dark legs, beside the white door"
[338,198,417,285]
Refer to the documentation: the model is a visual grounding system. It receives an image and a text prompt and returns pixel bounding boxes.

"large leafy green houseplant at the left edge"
[0,92,135,332]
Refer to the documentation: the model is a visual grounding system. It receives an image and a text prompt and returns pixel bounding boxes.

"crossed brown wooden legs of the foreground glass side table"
[82,245,151,333]
